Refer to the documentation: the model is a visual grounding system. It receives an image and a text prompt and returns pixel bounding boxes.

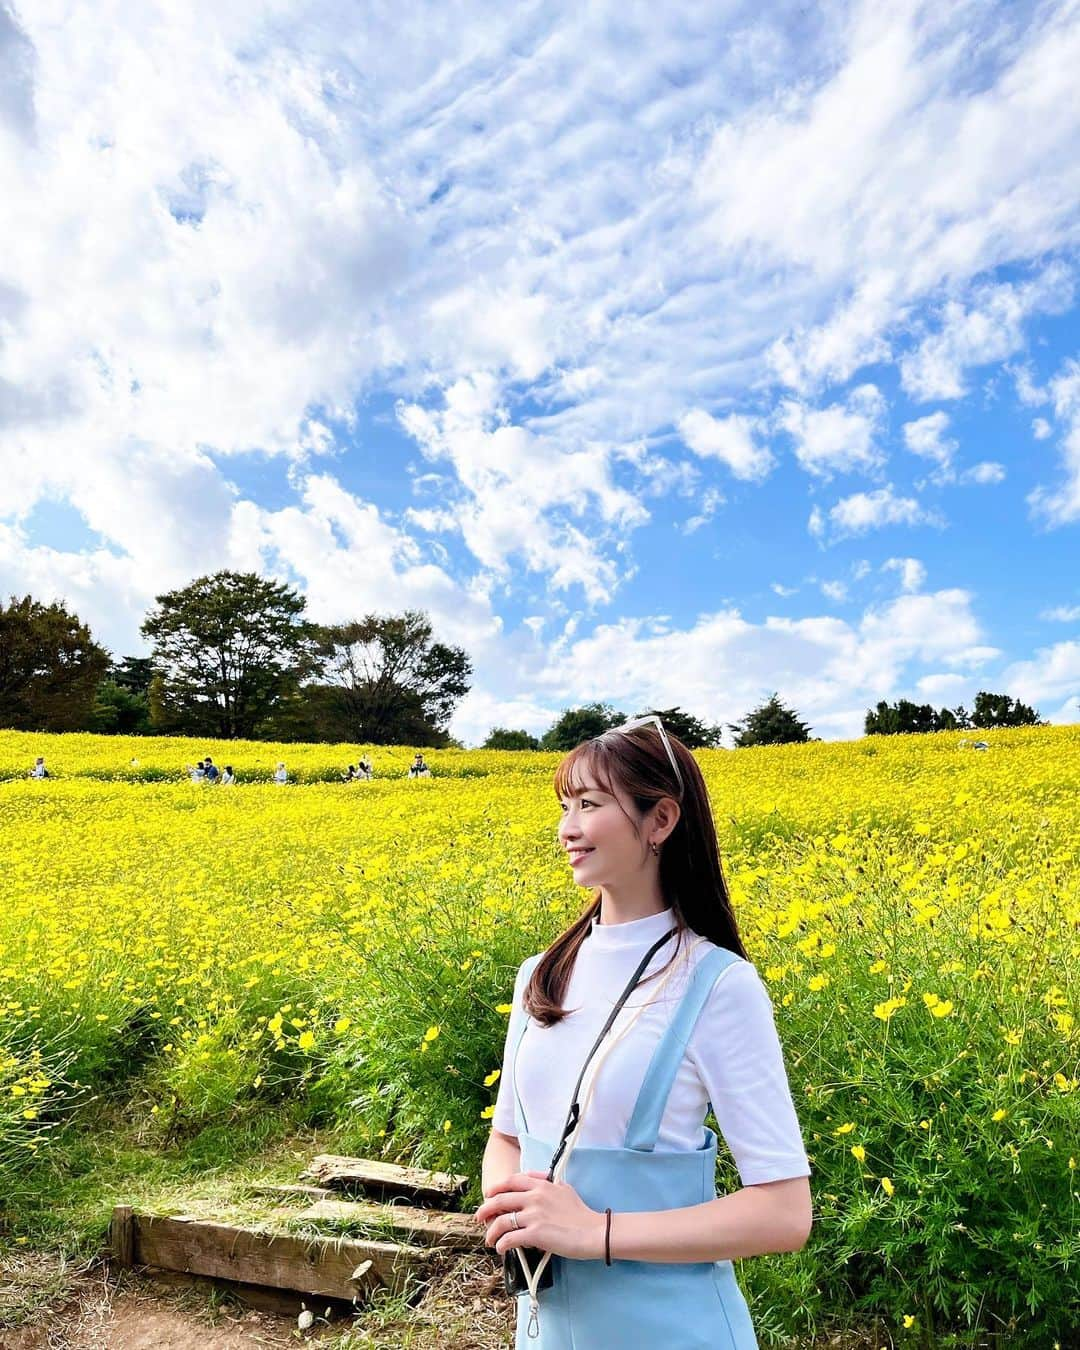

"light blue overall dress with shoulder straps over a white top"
[512,948,757,1350]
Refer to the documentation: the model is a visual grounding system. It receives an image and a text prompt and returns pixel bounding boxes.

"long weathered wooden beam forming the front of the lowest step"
[134,1214,435,1300]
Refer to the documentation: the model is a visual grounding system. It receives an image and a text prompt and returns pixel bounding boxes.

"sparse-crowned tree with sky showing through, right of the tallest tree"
[309,610,473,747]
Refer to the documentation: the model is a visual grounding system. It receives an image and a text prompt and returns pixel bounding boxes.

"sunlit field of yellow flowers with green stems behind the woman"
[0,726,1080,1346]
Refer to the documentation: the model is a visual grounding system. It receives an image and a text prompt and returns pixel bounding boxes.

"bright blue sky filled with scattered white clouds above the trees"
[0,0,1080,744]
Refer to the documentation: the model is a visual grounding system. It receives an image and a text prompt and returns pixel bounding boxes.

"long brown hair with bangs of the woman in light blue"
[525,725,747,1026]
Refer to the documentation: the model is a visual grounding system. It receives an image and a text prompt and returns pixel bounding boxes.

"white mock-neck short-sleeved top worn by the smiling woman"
[491,910,810,1185]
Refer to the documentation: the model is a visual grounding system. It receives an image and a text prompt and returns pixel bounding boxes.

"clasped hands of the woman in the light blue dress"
[477,1172,605,1261]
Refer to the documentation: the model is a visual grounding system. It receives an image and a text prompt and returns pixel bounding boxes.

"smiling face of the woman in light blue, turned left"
[559,772,649,887]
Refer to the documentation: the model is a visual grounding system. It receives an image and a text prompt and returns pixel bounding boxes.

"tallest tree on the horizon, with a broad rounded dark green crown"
[142,571,316,738]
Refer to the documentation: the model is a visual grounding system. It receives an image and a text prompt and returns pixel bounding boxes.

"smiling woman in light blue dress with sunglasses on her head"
[477,717,811,1350]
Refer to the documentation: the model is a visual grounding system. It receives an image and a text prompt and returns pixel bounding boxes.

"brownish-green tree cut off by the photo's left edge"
[0,595,109,732]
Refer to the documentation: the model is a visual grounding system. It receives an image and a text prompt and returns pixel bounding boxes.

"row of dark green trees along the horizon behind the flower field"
[0,571,1042,751]
